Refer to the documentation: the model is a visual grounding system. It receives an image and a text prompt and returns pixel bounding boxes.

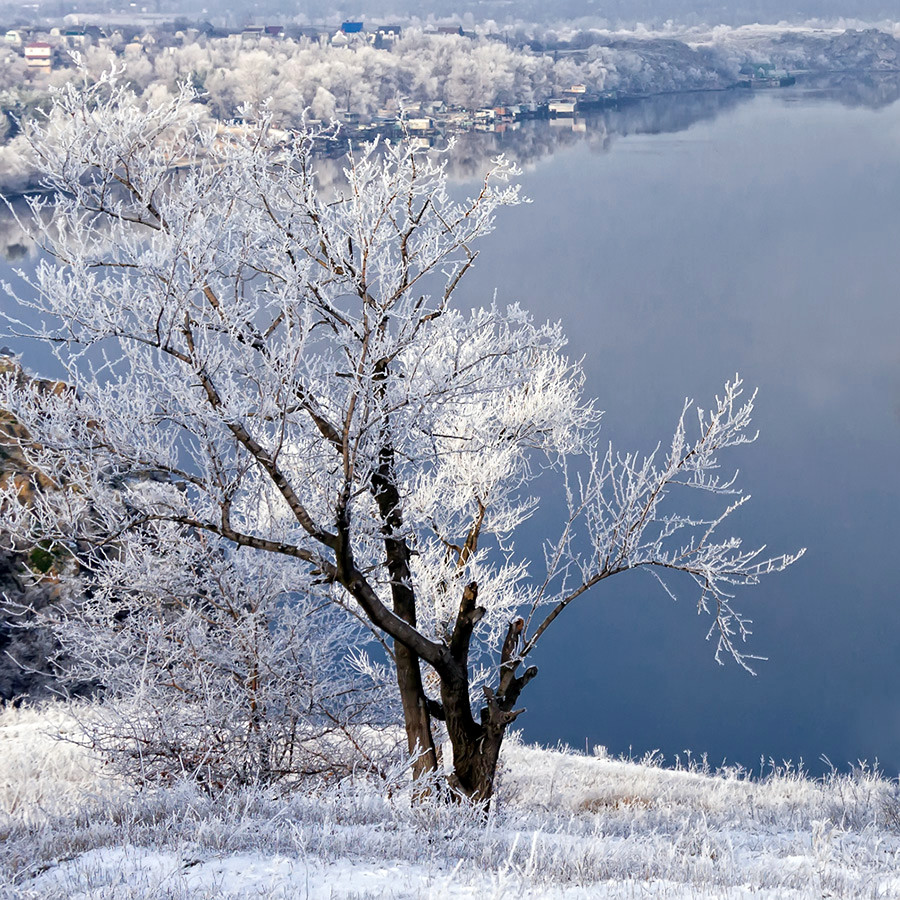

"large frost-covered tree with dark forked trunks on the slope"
[0,78,796,801]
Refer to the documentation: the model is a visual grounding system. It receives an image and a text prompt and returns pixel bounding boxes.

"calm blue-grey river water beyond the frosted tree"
[0,81,900,774]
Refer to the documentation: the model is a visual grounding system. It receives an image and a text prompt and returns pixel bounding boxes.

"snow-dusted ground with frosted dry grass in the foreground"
[0,709,900,900]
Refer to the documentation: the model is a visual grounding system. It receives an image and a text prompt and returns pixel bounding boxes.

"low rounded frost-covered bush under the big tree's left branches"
[21,526,393,789]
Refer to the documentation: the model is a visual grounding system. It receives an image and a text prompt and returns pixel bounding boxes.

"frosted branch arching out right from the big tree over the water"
[532,376,804,671]
